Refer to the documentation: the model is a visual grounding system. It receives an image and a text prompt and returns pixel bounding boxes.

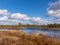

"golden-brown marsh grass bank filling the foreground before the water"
[0,30,60,45]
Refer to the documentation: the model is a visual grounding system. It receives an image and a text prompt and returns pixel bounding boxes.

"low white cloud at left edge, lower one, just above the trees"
[0,16,20,25]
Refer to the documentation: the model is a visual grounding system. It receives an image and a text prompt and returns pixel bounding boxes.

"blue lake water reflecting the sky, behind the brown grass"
[21,28,60,38]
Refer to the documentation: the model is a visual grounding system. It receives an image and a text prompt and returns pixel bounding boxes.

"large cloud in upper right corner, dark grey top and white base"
[47,0,60,18]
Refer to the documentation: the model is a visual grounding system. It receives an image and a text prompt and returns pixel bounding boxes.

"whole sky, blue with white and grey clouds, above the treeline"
[0,0,60,25]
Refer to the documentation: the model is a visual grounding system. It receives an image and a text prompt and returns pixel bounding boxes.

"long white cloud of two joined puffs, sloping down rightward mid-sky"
[11,13,48,24]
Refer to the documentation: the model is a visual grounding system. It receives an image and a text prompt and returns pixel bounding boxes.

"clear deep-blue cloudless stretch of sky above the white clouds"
[0,0,55,16]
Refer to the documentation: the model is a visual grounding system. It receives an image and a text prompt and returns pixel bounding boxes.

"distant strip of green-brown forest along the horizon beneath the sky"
[0,23,60,28]
